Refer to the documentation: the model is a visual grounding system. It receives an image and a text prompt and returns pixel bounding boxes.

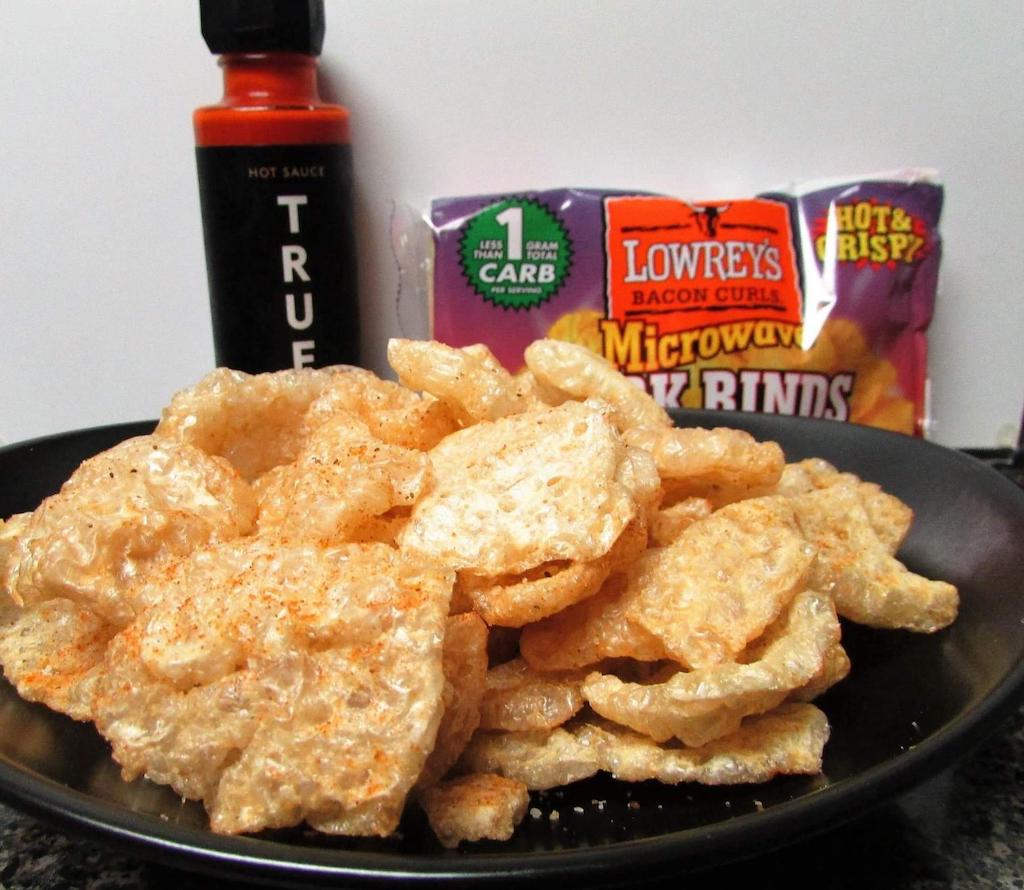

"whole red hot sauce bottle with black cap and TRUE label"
[193,0,358,373]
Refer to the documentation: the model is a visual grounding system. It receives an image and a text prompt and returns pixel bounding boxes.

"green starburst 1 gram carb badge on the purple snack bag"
[459,198,572,309]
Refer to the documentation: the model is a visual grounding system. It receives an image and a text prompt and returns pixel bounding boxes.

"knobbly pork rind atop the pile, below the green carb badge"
[387,339,530,426]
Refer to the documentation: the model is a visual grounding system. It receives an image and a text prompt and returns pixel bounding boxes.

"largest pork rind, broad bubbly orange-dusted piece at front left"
[95,538,454,835]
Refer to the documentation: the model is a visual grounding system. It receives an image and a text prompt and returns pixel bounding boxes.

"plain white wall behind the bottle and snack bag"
[0,0,1024,446]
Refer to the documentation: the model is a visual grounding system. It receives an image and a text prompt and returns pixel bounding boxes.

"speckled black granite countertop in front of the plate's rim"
[0,709,1024,890]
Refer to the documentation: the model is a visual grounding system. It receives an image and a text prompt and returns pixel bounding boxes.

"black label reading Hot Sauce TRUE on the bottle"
[196,144,359,374]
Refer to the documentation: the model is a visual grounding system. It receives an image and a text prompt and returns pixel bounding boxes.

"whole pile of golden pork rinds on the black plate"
[0,340,957,846]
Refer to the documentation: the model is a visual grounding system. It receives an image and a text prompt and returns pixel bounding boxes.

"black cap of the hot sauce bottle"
[199,0,324,55]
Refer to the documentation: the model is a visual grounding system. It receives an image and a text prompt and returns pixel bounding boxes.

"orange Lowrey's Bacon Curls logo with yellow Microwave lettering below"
[601,197,802,373]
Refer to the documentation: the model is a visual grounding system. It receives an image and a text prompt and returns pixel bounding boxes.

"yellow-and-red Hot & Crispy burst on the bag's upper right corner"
[814,198,930,269]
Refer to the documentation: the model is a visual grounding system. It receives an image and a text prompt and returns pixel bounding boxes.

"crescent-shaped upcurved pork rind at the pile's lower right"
[583,591,840,747]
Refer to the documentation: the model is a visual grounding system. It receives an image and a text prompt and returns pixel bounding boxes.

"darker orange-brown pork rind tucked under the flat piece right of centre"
[519,573,669,671]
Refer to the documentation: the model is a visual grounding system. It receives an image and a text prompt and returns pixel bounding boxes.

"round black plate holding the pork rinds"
[0,412,1024,884]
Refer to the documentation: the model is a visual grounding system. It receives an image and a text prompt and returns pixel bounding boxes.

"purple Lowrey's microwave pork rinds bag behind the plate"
[430,171,942,435]
